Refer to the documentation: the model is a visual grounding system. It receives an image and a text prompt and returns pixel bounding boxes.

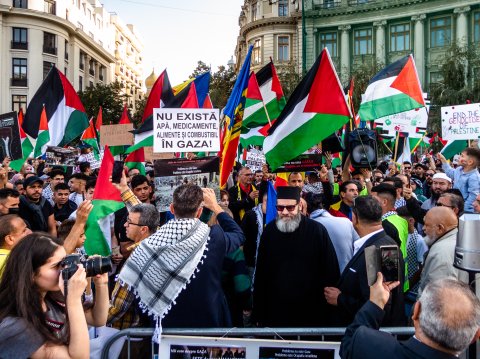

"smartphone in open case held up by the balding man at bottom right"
[365,245,400,286]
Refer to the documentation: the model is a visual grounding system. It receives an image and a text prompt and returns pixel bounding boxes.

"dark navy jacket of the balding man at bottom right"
[340,301,457,359]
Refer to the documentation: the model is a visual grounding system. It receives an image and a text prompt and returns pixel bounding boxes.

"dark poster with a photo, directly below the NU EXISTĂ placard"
[153,156,220,212]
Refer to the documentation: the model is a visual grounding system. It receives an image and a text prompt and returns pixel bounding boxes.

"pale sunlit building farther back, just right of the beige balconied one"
[110,13,144,110]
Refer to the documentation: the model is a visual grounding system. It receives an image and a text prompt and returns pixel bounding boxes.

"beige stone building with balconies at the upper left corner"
[0,0,144,113]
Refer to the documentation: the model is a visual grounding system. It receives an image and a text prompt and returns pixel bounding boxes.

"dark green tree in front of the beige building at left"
[78,81,128,124]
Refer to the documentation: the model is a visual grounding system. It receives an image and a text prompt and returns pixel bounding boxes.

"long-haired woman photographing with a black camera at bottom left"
[0,233,108,358]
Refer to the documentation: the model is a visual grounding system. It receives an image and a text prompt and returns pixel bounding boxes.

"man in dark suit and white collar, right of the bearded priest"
[324,195,406,326]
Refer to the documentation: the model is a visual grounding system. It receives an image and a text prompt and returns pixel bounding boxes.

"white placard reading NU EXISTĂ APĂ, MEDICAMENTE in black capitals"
[153,108,220,153]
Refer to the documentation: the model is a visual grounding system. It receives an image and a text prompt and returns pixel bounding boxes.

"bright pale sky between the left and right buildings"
[101,0,244,86]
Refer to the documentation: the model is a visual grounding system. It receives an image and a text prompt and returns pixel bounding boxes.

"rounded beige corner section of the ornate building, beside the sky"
[235,0,301,71]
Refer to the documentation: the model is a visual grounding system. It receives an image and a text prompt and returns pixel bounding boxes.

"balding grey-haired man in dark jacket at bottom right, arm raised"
[340,273,480,359]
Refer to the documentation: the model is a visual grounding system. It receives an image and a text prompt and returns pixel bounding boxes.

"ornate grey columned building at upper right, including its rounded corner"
[237,0,480,91]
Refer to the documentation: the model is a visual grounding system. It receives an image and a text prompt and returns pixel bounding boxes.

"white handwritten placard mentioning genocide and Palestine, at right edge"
[442,103,480,140]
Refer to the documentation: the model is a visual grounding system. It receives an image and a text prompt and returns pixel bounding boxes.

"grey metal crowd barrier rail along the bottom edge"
[101,327,415,359]
